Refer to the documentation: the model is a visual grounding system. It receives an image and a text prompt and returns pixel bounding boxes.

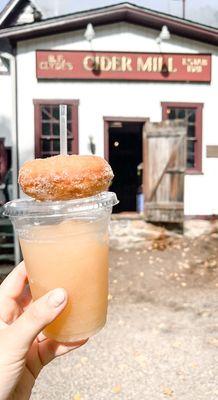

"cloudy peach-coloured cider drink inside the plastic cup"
[20,221,108,342]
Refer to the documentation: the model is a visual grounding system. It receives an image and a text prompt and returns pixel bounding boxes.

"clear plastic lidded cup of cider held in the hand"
[4,192,118,342]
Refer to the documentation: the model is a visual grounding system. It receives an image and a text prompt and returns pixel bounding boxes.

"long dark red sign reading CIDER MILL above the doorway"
[36,51,211,82]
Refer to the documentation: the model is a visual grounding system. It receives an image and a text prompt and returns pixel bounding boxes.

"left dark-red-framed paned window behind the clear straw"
[34,100,79,158]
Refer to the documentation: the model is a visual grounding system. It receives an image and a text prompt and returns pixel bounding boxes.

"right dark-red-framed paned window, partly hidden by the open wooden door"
[162,103,203,172]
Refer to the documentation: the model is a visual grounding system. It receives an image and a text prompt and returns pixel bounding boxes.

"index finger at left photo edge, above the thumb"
[0,261,27,299]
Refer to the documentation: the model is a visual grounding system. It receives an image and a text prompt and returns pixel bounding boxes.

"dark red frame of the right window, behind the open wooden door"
[161,101,204,174]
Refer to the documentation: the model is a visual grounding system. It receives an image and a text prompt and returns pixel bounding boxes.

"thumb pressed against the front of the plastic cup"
[9,289,67,352]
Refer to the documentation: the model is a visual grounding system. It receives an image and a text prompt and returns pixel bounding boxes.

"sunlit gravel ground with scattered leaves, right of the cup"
[31,232,218,400]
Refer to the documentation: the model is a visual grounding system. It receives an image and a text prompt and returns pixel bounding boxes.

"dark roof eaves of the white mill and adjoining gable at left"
[0,0,218,45]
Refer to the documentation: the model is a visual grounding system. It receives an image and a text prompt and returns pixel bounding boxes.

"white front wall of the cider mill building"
[17,23,218,215]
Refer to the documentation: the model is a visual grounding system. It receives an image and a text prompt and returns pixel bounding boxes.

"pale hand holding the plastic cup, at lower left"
[0,263,86,400]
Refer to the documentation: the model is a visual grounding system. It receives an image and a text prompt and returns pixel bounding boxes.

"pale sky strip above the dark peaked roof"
[0,0,218,27]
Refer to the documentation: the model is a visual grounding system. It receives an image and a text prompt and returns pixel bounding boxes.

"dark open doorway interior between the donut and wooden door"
[108,121,143,213]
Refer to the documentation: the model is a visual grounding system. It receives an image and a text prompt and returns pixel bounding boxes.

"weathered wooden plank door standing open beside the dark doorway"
[143,120,186,223]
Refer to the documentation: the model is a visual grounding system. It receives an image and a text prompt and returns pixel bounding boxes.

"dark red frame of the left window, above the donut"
[33,99,79,158]
